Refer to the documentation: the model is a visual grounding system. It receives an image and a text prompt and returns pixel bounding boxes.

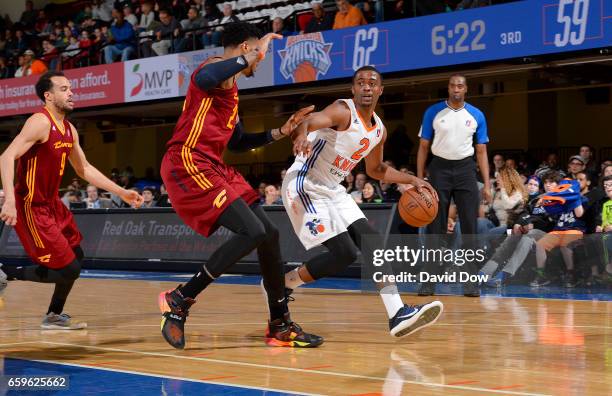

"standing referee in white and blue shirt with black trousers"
[417,74,491,297]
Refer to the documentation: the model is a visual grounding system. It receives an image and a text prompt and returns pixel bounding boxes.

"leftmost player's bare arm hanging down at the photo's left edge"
[0,113,51,226]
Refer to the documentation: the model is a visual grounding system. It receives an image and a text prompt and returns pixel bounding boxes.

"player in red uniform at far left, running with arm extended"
[0,71,142,330]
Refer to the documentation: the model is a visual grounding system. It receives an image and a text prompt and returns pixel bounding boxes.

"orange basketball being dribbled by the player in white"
[397,188,438,227]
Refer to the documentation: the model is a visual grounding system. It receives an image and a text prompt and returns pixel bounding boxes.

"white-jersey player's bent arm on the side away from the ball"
[291,100,351,156]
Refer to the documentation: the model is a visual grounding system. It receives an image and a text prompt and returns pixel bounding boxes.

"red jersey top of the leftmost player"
[15,108,74,204]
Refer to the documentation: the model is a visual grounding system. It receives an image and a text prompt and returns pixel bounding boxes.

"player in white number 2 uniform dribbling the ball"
[282,66,443,337]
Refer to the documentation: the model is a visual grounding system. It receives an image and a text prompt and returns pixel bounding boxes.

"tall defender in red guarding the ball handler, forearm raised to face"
[159,23,323,349]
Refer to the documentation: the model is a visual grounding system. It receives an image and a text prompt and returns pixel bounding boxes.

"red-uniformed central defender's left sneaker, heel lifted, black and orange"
[158,285,195,349]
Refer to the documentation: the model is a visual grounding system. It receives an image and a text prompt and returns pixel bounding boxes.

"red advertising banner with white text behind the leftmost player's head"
[0,63,124,117]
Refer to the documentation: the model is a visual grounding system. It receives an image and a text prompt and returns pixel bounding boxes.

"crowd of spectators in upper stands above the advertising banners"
[0,0,502,78]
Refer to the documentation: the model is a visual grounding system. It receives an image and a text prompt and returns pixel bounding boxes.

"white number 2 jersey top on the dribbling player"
[289,99,384,188]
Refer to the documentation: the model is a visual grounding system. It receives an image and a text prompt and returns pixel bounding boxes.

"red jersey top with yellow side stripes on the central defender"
[167,60,238,164]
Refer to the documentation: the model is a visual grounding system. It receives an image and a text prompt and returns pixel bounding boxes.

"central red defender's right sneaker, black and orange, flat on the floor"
[266,313,323,348]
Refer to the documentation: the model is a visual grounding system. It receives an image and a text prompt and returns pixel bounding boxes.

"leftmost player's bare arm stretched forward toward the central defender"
[68,124,143,208]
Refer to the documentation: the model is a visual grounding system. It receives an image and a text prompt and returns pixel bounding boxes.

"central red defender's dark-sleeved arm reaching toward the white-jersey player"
[227,106,314,151]
